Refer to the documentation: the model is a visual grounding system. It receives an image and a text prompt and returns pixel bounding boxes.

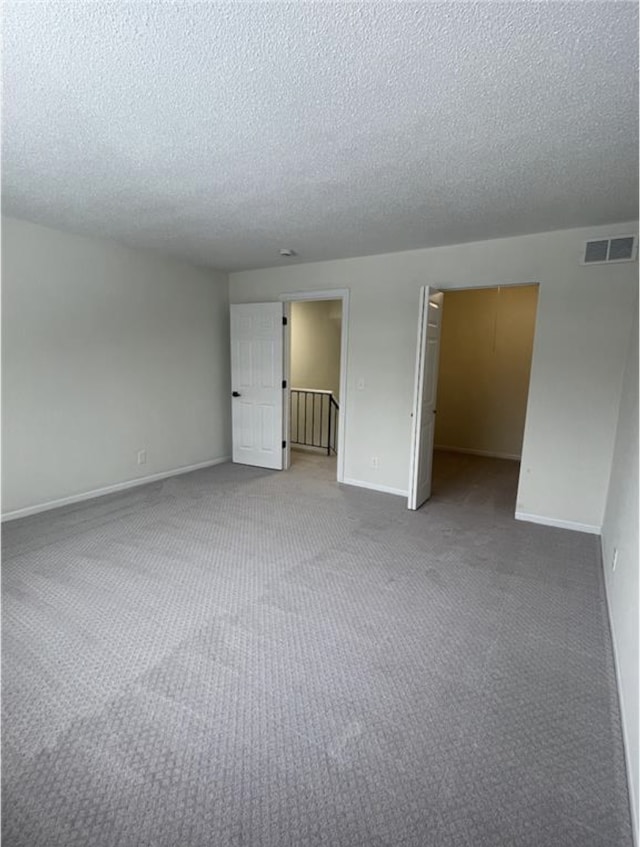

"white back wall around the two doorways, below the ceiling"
[229,222,638,531]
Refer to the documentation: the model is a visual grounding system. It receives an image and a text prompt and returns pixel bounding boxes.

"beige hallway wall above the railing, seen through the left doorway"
[291,300,342,397]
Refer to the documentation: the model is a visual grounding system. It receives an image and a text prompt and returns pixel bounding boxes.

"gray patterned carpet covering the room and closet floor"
[3,454,631,847]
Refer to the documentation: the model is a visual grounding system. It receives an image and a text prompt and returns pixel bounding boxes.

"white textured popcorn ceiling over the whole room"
[2,0,638,269]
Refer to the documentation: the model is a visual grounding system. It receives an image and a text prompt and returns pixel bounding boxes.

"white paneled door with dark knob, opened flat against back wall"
[231,303,284,470]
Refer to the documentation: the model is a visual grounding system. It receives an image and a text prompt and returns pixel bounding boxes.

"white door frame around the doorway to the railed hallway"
[279,288,351,482]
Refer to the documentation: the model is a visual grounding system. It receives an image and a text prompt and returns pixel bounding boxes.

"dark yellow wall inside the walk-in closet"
[435,285,538,459]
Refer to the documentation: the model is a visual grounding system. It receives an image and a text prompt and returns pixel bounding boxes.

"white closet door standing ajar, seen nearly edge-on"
[408,286,444,509]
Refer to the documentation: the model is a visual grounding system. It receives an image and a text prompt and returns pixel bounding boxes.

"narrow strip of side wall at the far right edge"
[602,306,640,843]
